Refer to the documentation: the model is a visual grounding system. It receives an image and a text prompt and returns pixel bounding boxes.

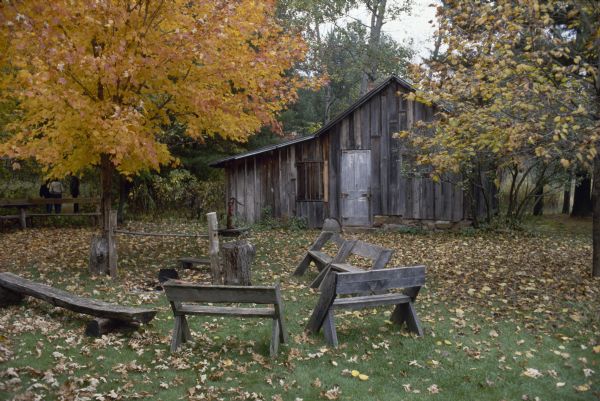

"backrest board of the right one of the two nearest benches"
[335,266,425,295]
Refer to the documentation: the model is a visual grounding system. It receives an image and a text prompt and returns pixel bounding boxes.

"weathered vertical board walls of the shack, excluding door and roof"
[226,77,486,227]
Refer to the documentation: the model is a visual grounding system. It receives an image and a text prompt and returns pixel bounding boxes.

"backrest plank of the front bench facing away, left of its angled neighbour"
[163,280,280,304]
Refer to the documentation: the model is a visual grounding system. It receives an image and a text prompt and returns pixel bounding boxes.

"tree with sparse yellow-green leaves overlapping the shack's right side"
[406,0,600,220]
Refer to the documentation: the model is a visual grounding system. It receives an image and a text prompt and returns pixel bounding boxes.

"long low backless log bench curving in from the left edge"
[0,272,157,336]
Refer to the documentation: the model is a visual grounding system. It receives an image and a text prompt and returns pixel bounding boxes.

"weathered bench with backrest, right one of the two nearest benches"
[306,266,425,347]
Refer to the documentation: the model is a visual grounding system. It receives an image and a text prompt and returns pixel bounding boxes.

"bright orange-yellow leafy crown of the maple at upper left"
[0,0,310,177]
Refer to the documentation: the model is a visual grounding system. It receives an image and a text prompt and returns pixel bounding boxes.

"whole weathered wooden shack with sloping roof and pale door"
[212,76,492,227]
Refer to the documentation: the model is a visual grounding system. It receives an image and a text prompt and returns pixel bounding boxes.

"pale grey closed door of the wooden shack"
[340,150,371,226]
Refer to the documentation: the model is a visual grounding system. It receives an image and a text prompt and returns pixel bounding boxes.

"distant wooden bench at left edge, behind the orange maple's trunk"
[0,198,100,229]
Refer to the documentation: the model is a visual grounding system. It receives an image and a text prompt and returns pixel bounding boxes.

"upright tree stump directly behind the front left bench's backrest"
[221,241,256,285]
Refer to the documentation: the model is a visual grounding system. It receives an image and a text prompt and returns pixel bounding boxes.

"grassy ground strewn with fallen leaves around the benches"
[0,219,600,401]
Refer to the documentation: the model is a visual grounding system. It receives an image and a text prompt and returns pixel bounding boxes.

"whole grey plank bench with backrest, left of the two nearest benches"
[163,280,288,356]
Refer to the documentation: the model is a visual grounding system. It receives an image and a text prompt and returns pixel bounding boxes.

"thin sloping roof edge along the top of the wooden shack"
[209,75,415,168]
